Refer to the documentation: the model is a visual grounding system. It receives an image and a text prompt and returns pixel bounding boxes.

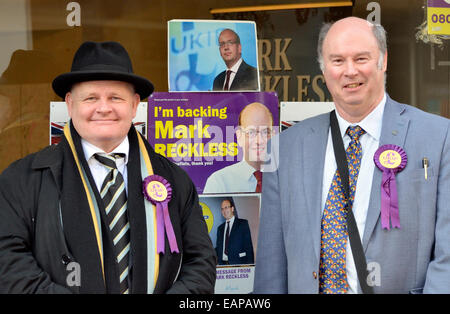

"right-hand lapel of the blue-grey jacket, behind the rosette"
[362,95,409,251]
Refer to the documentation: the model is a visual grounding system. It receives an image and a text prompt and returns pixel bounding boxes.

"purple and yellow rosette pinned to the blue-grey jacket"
[373,144,408,230]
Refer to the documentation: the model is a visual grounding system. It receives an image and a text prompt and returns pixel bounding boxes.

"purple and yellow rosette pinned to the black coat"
[142,174,180,254]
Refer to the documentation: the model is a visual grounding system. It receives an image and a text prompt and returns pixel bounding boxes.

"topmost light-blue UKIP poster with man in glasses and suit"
[168,20,260,92]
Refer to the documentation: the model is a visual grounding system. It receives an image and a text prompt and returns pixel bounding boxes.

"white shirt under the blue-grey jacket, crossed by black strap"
[322,94,386,293]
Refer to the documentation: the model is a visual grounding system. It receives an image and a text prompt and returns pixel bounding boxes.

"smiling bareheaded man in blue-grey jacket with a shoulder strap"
[254,17,450,293]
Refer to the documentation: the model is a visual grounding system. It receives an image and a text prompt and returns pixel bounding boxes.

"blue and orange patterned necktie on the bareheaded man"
[319,126,365,293]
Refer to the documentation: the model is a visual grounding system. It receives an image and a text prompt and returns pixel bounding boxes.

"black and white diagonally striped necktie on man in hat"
[95,154,130,293]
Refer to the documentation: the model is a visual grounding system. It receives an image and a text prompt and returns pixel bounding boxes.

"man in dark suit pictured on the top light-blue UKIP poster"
[213,28,259,91]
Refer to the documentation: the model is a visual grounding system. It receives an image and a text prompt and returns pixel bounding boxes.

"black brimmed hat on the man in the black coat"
[52,41,153,99]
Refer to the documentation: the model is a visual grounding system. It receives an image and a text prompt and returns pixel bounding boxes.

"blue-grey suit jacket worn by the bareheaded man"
[254,96,450,293]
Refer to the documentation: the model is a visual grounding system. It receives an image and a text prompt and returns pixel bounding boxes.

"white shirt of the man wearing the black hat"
[81,137,130,193]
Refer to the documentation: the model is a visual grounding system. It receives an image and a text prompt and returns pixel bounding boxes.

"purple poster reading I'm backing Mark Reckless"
[148,92,279,194]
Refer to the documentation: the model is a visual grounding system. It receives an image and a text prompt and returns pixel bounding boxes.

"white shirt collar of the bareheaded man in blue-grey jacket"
[336,93,386,141]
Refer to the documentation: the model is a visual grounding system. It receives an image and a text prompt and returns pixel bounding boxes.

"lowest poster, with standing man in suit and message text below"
[199,193,261,294]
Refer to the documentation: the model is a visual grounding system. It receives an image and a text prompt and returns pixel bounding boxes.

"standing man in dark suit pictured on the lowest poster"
[216,198,254,265]
